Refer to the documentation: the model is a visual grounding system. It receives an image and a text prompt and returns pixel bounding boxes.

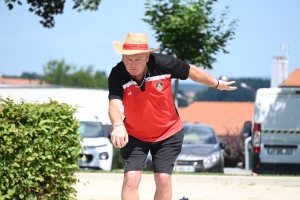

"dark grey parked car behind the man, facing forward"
[145,123,226,173]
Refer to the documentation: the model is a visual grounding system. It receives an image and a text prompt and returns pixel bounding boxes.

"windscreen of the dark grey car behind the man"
[183,126,217,144]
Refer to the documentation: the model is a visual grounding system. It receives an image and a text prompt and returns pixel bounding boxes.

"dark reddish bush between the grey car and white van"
[222,133,245,167]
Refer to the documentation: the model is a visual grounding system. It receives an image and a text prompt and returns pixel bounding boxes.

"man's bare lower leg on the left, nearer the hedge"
[122,171,142,200]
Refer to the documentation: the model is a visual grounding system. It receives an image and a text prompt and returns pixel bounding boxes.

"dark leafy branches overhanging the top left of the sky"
[4,0,101,28]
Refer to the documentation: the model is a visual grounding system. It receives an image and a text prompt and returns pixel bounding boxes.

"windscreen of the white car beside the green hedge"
[79,121,104,138]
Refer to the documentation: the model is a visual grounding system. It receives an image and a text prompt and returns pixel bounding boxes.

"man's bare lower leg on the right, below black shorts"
[154,173,172,200]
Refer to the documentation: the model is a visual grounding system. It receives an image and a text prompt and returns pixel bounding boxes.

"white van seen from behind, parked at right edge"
[244,88,300,174]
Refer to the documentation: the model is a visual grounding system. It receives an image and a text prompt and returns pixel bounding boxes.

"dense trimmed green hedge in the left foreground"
[0,98,82,200]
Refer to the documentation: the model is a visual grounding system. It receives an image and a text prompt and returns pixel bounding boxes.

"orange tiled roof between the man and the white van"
[178,101,254,136]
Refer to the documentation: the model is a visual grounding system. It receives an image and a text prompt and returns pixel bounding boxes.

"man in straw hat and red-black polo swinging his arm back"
[108,33,236,200]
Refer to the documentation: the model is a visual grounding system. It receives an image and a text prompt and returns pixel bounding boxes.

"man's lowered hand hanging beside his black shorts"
[111,124,128,148]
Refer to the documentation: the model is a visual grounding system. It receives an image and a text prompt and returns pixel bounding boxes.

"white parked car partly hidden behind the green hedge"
[78,116,113,171]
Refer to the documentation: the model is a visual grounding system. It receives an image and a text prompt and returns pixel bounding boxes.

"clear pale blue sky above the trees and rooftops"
[0,0,300,83]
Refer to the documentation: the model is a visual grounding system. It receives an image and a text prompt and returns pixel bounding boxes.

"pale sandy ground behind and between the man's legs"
[75,171,300,200]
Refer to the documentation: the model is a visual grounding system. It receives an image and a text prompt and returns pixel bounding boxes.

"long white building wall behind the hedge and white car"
[0,84,111,124]
